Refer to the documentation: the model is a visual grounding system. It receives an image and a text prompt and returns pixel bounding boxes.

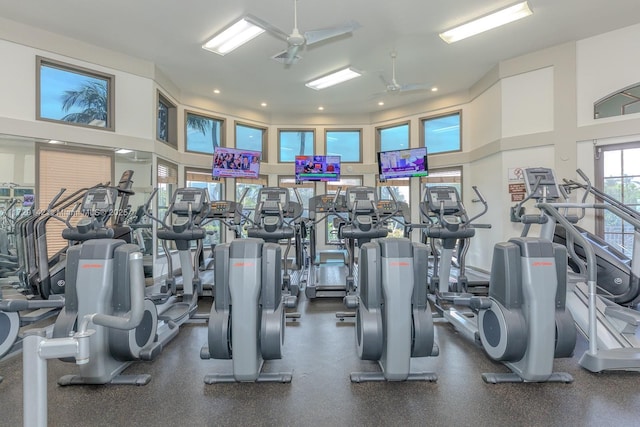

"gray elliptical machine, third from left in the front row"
[343,188,439,382]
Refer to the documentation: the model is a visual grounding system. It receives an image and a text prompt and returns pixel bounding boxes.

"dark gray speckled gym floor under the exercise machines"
[0,299,640,426]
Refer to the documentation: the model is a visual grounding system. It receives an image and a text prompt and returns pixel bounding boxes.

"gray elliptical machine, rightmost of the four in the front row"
[428,187,576,383]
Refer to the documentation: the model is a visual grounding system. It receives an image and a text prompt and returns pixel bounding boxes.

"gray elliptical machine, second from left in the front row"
[200,189,295,384]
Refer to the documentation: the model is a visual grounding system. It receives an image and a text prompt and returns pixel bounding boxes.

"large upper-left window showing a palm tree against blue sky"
[36,56,115,130]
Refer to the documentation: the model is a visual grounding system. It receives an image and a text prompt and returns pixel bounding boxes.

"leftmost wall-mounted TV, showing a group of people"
[212,147,261,178]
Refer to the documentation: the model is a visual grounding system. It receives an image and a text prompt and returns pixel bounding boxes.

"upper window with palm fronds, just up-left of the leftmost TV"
[185,111,225,154]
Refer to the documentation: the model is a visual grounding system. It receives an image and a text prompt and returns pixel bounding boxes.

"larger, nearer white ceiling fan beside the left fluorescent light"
[245,0,360,65]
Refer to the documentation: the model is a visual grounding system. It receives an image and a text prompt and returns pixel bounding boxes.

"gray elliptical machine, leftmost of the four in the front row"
[53,187,158,386]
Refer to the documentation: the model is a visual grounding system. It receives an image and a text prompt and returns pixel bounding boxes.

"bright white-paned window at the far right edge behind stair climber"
[595,143,640,257]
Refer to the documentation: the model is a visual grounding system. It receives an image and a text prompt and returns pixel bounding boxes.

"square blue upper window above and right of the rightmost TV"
[420,111,462,154]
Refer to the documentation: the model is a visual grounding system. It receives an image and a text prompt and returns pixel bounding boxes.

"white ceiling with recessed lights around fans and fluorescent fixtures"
[0,0,640,115]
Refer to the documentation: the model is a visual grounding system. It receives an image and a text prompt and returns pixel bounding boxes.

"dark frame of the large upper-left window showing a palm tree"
[36,55,116,132]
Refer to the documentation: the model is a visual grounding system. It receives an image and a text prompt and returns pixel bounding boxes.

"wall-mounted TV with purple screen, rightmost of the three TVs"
[378,147,429,181]
